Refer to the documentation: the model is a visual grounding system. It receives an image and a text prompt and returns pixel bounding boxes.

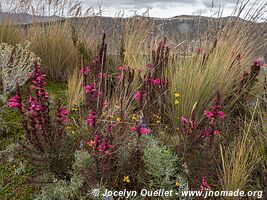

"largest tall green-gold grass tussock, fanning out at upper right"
[168,16,267,125]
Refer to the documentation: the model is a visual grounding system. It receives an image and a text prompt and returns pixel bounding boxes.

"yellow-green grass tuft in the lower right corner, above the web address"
[220,102,261,191]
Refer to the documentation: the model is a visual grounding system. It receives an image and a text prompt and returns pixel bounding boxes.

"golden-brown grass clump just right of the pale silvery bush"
[27,22,80,80]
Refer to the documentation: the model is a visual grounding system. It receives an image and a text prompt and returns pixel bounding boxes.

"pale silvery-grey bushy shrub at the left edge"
[0,42,40,94]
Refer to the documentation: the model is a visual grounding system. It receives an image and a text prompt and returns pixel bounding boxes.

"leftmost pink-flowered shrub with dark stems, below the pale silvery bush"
[7,63,73,179]
